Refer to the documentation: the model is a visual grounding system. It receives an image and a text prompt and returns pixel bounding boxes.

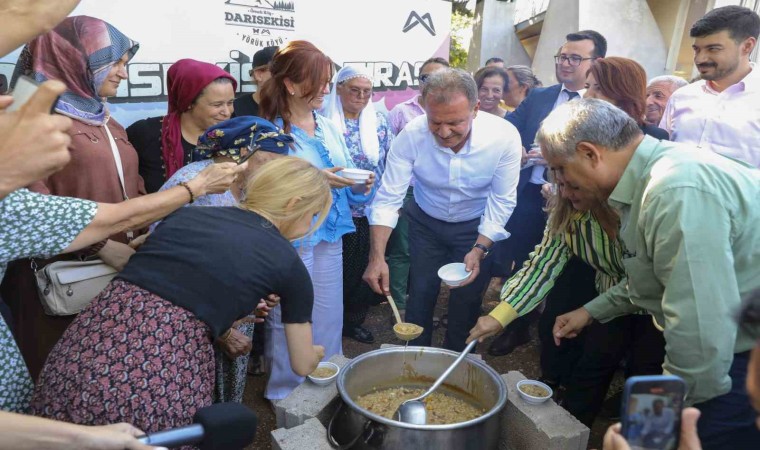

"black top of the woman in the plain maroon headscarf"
[127,116,195,194]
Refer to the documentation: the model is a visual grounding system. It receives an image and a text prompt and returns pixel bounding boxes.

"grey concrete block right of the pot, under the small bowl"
[499,371,589,450]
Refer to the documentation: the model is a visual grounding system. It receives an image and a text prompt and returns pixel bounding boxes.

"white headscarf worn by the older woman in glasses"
[324,66,380,165]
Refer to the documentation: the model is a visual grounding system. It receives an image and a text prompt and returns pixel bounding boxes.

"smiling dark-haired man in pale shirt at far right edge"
[660,6,760,167]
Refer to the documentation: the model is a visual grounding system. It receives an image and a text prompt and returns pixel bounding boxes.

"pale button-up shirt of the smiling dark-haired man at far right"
[660,64,760,167]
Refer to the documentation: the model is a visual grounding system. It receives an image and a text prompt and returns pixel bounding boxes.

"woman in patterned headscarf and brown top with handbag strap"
[2,16,145,378]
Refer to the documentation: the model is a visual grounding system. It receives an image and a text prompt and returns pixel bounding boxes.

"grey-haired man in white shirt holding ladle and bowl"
[364,69,521,350]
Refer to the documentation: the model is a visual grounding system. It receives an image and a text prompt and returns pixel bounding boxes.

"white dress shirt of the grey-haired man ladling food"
[369,112,522,242]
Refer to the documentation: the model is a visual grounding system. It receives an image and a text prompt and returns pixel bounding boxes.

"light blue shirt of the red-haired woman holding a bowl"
[284,113,374,247]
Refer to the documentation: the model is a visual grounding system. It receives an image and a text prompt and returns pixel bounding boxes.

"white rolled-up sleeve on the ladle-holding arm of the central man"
[368,130,415,228]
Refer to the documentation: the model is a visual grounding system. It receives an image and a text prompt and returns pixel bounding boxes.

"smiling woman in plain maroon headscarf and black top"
[127,59,237,193]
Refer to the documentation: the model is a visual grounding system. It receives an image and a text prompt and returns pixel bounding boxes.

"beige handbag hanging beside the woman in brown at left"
[32,259,118,316]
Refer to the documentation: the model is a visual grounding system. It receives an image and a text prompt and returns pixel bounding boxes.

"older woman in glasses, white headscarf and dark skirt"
[322,66,393,344]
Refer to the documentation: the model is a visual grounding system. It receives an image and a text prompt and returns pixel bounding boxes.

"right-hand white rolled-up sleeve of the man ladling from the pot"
[478,126,522,242]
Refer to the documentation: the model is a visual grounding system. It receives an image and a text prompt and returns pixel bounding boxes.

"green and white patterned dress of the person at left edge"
[0,189,98,412]
